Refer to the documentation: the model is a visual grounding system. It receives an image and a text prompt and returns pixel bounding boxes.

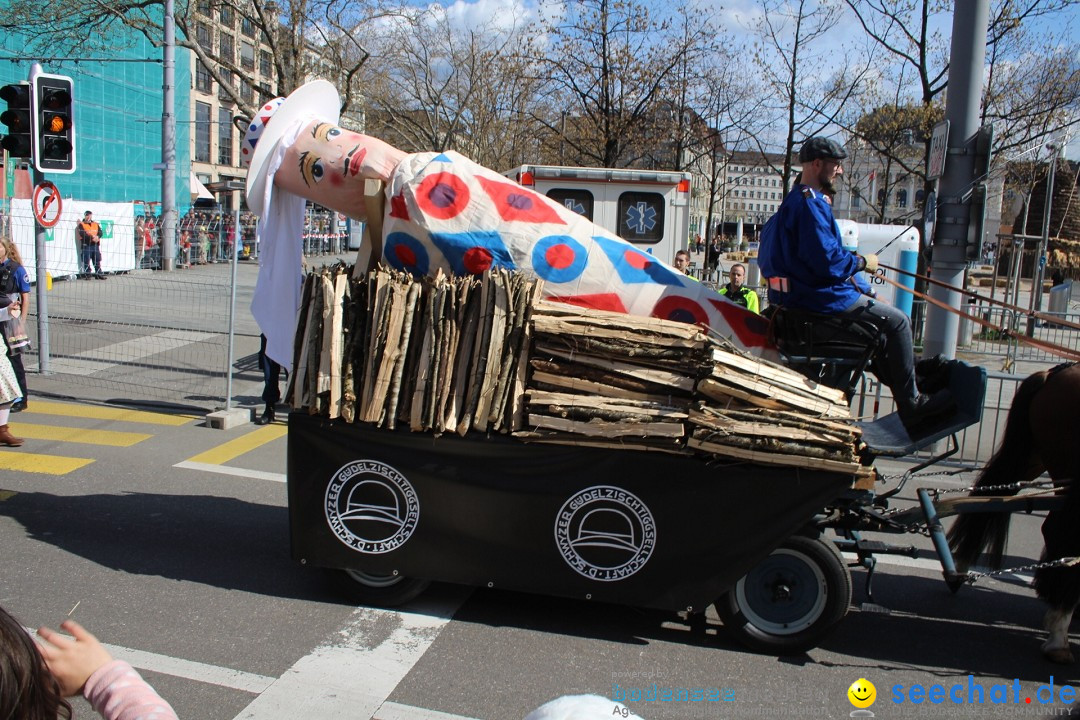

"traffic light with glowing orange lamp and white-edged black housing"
[31,72,75,173]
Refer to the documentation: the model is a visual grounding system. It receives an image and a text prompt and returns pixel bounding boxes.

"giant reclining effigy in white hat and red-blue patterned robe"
[241,80,769,368]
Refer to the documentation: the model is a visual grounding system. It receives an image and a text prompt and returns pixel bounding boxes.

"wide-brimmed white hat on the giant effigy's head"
[240,80,341,215]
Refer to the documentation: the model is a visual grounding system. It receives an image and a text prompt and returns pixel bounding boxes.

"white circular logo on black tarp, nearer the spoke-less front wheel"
[555,485,657,582]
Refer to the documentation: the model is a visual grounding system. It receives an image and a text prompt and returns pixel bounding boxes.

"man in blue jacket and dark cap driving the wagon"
[758,137,951,427]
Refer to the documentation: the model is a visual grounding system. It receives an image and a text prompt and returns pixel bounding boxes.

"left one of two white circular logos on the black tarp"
[324,460,420,555]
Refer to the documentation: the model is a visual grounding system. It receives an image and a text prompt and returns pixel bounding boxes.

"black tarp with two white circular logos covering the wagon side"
[288,412,851,611]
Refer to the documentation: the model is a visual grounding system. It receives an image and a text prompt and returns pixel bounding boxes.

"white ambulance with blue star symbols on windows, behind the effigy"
[503,165,690,264]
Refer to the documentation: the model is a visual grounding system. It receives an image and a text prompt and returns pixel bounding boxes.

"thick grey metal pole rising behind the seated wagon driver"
[923,0,990,357]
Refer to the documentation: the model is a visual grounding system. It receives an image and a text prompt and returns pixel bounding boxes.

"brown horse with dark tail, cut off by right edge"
[948,363,1080,664]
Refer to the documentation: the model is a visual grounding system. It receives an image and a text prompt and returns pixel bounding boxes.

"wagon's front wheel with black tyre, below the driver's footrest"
[716,535,851,655]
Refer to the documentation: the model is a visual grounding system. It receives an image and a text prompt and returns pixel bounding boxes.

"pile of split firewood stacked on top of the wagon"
[287,264,865,475]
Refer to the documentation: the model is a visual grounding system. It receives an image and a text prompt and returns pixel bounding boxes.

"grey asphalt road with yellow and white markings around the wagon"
[0,399,1080,720]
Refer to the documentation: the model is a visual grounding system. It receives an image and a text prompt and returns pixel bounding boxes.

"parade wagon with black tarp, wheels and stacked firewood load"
[276,267,985,653]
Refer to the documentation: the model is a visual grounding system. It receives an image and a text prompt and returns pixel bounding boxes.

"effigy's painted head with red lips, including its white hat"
[241,80,405,219]
